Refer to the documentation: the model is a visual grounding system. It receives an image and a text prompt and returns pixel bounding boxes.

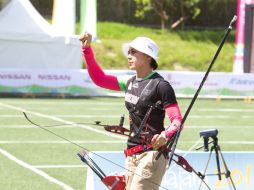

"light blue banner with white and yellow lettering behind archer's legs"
[84,151,254,190]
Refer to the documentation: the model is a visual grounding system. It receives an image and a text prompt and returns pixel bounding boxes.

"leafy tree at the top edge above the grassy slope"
[135,0,200,30]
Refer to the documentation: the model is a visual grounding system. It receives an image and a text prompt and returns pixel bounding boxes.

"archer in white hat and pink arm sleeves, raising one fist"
[80,33,182,190]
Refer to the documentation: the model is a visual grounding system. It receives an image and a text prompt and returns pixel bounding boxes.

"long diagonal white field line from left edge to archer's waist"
[0,103,126,139]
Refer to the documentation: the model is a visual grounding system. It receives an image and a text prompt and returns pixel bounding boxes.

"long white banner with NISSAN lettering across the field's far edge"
[0,69,254,97]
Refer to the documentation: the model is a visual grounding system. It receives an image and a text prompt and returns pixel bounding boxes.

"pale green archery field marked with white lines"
[0,98,254,190]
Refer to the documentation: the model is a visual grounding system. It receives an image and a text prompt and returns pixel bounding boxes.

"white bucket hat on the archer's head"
[123,37,159,62]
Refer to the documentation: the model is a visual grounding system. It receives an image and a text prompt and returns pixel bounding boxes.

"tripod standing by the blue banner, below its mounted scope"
[197,136,236,190]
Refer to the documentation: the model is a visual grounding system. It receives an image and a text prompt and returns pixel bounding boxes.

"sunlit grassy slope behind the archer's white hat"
[81,22,235,72]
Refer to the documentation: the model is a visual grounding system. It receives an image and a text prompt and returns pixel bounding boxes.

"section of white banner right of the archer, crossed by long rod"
[161,71,254,96]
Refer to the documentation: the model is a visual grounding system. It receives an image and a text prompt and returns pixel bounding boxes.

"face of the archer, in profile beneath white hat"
[127,47,151,70]
